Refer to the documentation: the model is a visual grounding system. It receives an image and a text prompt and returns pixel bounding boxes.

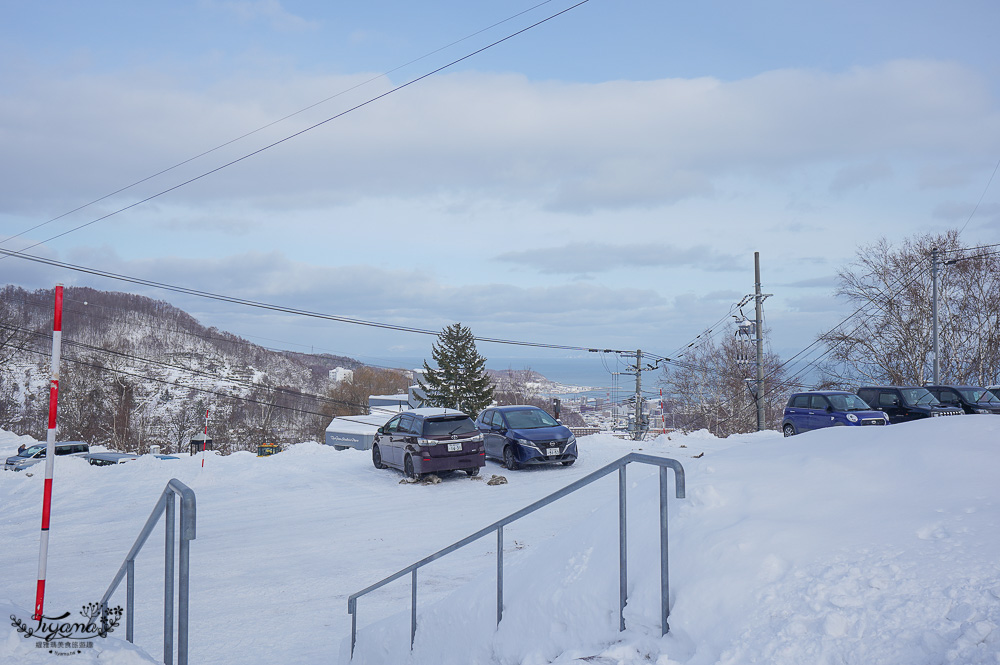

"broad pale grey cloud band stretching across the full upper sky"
[0,59,1000,214]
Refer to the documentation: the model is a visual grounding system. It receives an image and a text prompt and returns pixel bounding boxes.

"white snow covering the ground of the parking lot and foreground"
[0,415,1000,665]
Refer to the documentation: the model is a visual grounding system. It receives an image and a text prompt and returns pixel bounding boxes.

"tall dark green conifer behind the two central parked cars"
[419,323,493,417]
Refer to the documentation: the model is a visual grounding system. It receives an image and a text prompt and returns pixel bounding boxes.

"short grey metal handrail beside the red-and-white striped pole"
[101,478,197,665]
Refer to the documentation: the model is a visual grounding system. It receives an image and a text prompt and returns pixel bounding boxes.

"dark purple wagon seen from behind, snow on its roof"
[372,408,486,478]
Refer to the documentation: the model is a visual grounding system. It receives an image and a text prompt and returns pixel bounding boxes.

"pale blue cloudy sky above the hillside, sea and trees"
[0,0,1000,378]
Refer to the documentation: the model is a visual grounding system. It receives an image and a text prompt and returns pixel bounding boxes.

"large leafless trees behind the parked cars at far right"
[820,231,1000,385]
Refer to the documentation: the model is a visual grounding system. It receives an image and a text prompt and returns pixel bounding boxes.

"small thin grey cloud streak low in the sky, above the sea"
[496,242,742,274]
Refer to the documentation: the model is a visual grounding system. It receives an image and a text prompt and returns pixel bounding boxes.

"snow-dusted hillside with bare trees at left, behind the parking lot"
[0,286,398,452]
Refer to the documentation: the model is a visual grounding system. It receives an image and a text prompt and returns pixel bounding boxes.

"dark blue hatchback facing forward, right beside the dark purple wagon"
[476,406,578,471]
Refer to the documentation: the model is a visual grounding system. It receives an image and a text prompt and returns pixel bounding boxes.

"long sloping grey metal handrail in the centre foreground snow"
[347,453,685,659]
